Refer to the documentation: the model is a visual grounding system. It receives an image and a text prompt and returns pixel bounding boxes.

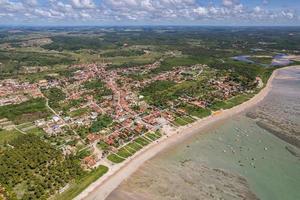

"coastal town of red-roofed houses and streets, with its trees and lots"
[0,57,258,172]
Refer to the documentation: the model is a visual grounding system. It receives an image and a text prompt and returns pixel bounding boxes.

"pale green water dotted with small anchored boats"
[173,116,300,200]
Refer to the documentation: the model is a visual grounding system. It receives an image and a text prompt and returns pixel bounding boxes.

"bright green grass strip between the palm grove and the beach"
[54,165,108,200]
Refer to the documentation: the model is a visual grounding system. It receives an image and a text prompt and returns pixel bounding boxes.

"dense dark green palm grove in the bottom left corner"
[0,135,83,199]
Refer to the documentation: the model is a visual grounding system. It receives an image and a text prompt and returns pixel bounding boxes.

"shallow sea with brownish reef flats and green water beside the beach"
[108,68,300,200]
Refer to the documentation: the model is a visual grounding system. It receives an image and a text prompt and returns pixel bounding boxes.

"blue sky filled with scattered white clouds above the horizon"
[0,0,300,26]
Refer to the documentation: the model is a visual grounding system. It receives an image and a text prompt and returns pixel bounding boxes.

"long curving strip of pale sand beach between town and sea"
[75,68,284,200]
